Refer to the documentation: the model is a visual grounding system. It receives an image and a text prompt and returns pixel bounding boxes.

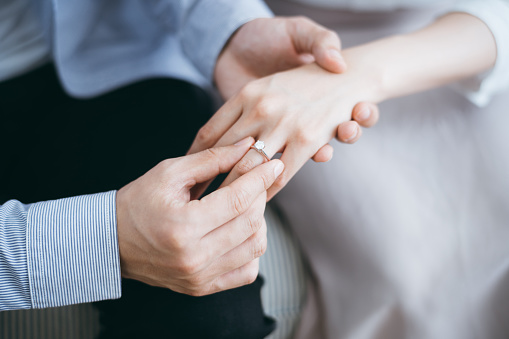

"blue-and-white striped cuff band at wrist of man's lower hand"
[26,191,121,308]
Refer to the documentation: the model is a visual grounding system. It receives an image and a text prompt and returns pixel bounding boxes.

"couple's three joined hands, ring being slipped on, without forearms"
[117,18,378,296]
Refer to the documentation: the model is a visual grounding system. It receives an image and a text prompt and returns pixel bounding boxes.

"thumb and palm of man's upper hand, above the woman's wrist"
[214,17,346,100]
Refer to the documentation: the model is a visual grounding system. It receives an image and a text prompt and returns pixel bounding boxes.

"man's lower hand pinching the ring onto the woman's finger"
[117,138,283,296]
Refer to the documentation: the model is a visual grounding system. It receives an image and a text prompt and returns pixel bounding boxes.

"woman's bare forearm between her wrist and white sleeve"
[344,13,497,102]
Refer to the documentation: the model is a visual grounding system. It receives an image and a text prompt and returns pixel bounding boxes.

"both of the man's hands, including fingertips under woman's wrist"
[117,18,378,296]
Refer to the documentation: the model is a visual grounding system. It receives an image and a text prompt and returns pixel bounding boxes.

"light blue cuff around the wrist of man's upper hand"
[181,0,273,82]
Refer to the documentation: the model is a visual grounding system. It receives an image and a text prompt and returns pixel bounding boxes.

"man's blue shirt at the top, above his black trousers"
[41,0,271,97]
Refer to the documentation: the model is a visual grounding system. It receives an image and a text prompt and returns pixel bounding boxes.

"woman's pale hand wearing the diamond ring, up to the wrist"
[189,64,377,198]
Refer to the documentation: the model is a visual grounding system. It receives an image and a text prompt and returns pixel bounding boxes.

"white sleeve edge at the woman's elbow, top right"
[451,0,509,107]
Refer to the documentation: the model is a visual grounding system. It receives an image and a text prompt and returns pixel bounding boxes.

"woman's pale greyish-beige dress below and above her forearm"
[269,1,509,339]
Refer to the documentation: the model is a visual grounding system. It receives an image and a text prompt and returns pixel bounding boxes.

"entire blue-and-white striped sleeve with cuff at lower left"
[0,191,121,310]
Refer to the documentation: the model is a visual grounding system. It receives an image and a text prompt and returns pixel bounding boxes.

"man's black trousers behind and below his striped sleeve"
[0,65,274,339]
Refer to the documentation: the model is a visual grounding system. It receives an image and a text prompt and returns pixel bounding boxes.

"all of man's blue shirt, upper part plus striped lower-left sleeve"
[0,0,271,310]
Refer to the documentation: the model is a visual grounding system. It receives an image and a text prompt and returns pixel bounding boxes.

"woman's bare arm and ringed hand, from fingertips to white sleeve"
[190,13,496,199]
